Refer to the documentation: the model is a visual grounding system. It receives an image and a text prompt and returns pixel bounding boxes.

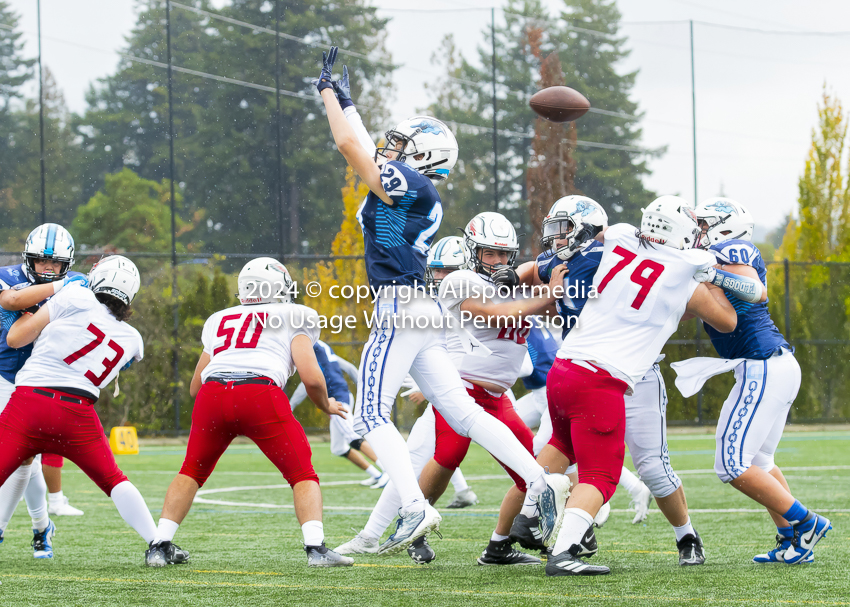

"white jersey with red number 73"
[15,284,144,397]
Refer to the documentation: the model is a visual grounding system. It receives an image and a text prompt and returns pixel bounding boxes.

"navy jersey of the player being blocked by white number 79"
[537,240,604,337]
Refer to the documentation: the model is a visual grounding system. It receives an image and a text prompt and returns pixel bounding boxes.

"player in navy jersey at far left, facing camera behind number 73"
[0,223,86,559]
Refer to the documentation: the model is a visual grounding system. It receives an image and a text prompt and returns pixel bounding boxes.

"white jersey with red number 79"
[558,223,717,387]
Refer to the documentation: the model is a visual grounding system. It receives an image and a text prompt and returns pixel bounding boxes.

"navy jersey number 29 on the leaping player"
[357,160,443,289]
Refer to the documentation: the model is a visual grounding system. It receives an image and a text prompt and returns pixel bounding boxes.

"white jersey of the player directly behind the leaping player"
[440,270,531,390]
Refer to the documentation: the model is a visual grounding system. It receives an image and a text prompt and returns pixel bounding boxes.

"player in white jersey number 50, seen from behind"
[145,257,354,567]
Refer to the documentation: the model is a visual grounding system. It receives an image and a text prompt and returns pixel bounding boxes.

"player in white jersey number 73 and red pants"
[0,255,172,560]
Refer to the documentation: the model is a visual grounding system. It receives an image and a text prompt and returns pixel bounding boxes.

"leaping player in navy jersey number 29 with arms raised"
[315,47,569,553]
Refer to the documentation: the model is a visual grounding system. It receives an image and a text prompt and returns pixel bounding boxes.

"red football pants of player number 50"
[180,382,319,486]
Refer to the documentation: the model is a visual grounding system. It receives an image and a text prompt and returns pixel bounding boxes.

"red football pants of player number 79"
[546,358,628,502]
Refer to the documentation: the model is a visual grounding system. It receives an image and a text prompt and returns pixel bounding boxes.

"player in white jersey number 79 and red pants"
[524,199,736,576]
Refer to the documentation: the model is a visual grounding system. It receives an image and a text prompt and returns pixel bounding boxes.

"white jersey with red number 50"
[201,303,321,387]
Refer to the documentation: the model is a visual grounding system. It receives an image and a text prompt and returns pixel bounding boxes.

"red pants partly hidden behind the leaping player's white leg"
[434,386,534,493]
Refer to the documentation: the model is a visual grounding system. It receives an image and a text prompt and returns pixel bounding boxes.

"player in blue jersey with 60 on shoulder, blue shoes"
[673,198,832,564]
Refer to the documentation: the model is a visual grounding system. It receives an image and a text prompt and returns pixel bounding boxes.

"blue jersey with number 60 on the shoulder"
[703,240,791,360]
